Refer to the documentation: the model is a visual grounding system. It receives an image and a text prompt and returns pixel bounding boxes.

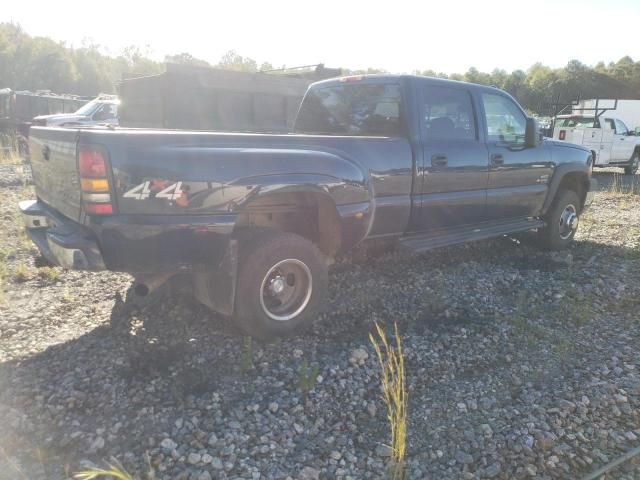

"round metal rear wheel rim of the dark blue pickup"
[260,258,313,322]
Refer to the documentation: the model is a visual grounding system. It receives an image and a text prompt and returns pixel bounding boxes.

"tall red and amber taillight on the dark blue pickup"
[78,146,113,215]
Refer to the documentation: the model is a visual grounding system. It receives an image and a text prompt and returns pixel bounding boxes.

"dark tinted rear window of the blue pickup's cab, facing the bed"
[294,82,403,137]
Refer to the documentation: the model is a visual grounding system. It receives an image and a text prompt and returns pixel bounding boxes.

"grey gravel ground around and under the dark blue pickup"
[0,163,640,480]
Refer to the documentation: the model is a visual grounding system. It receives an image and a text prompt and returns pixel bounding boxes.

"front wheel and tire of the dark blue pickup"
[538,190,580,250]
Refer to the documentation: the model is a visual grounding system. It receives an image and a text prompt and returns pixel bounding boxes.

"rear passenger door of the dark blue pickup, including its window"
[418,84,488,230]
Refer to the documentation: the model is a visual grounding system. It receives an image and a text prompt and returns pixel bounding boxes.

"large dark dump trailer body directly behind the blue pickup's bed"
[118,64,340,133]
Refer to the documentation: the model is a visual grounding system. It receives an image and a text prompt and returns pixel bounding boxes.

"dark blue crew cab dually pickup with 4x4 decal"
[21,75,595,338]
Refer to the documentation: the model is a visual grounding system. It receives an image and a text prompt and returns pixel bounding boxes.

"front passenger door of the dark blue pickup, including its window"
[479,91,553,220]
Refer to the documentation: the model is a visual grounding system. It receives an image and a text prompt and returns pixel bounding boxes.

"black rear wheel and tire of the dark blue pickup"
[234,229,328,340]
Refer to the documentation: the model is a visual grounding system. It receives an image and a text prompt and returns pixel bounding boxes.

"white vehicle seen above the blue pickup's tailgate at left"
[32,95,120,127]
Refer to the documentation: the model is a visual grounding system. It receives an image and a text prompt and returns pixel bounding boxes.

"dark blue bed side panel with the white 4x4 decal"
[77,129,412,234]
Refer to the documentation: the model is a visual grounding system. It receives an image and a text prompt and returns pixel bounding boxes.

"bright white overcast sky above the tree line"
[0,0,640,73]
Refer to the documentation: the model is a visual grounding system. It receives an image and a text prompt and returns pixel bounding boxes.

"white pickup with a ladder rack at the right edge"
[553,114,640,175]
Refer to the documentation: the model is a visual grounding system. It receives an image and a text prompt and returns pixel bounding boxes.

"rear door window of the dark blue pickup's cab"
[422,86,477,140]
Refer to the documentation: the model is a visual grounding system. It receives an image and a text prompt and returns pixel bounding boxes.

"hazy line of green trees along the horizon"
[0,23,640,115]
